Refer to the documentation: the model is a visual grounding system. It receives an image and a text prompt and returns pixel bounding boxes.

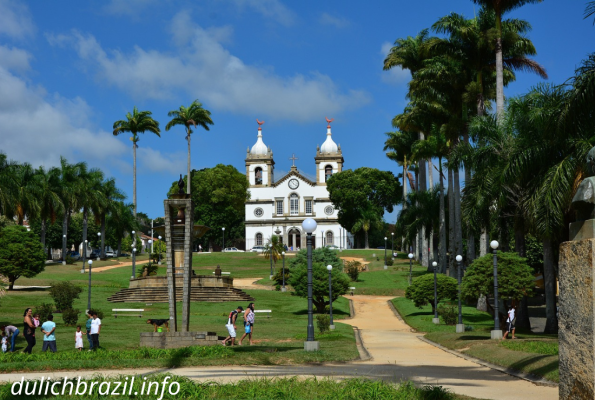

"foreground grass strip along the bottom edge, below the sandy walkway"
[0,375,458,400]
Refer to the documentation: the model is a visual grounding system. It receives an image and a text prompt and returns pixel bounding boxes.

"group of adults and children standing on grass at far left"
[1,308,101,354]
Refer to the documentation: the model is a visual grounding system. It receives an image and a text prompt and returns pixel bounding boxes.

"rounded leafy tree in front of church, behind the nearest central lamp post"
[289,260,349,314]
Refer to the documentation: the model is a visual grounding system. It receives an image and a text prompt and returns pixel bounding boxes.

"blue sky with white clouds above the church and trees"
[0,0,595,222]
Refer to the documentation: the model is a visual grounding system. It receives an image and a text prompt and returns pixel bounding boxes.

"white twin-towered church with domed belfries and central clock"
[246,119,353,251]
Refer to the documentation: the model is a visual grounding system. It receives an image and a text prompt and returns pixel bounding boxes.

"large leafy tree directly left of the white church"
[169,164,250,249]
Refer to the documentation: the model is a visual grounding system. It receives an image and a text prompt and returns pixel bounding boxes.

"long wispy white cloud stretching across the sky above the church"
[49,13,369,121]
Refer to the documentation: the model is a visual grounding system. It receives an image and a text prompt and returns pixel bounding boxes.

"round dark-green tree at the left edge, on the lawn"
[0,225,45,290]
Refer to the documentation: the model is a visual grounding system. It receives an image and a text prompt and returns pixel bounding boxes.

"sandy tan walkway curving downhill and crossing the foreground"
[0,296,558,400]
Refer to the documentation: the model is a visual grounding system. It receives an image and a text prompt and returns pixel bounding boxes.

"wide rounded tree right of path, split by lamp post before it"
[461,252,535,300]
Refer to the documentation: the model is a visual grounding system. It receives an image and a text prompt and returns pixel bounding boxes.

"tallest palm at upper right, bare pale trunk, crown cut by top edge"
[473,0,543,121]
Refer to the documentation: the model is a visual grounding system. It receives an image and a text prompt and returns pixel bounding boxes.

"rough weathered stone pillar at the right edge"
[558,239,595,400]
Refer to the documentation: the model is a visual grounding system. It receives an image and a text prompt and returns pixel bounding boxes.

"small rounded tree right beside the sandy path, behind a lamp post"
[405,274,458,313]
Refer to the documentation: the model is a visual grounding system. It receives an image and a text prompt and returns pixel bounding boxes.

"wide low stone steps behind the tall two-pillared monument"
[107,286,254,303]
